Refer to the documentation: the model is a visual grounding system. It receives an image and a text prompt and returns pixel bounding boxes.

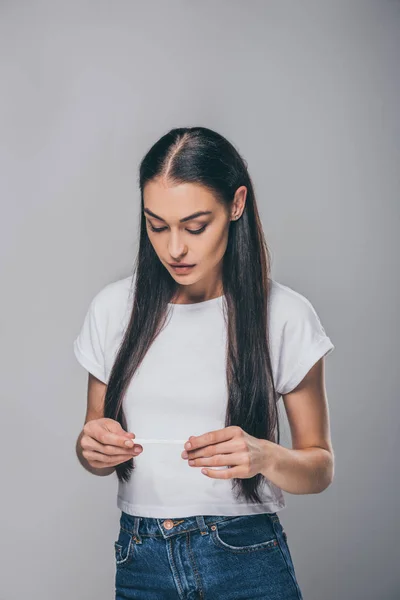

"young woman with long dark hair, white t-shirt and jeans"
[74,127,334,600]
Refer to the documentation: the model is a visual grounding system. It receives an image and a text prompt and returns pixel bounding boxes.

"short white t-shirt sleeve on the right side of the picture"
[275,292,335,395]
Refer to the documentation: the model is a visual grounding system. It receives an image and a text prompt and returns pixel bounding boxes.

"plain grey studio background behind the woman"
[0,0,400,600]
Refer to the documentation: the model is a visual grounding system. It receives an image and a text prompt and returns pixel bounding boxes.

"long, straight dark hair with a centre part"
[104,127,280,503]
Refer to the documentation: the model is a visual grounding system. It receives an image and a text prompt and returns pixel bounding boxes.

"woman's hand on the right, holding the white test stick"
[181,425,276,479]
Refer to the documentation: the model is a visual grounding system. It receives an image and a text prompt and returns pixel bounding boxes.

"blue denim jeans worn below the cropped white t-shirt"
[114,511,303,600]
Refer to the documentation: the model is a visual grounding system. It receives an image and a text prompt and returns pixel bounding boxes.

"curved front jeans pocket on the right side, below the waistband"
[210,513,279,553]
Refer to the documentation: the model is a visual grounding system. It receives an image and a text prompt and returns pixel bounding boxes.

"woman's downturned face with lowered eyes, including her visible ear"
[143,179,247,297]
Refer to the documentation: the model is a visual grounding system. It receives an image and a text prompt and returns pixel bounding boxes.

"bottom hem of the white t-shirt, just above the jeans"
[117,496,286,519]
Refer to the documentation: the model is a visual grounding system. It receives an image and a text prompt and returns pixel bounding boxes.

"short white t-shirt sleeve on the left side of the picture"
[73,292,107,383]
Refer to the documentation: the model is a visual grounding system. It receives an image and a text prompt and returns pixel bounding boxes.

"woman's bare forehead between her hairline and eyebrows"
[143,180,222,218]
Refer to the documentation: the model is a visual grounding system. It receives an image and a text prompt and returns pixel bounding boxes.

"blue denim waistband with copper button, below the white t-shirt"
[120,511,279,543]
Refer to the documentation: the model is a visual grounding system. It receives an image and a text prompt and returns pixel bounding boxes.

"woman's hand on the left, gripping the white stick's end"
[80,418,143,469]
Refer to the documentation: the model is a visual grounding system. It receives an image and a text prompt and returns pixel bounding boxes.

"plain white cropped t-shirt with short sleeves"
[74,275,334,518]
